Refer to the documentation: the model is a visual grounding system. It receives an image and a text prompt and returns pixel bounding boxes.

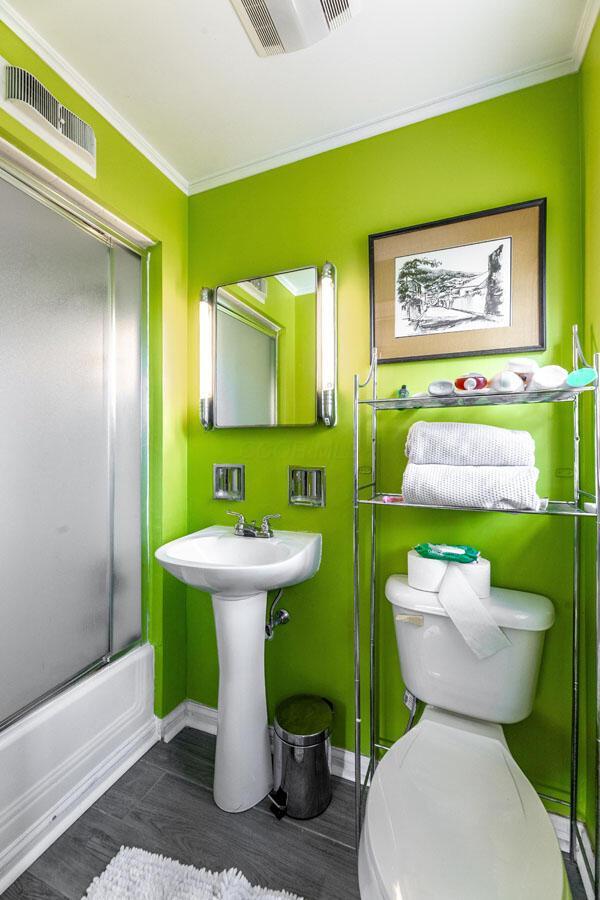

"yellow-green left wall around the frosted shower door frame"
[0,23,188,714]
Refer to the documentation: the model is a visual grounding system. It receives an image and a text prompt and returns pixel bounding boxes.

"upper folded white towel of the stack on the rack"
[406,422,535,466]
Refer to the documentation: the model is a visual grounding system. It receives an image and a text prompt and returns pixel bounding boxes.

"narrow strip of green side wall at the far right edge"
[581,14,600,844]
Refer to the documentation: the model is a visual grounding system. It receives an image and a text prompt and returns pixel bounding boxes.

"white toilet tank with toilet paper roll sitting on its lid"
[385,575,554,724]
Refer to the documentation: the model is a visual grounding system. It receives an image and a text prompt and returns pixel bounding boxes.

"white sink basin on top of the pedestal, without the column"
[156,525,321,597]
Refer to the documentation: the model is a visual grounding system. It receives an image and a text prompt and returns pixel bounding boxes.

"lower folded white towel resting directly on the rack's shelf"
[402,462,547,511]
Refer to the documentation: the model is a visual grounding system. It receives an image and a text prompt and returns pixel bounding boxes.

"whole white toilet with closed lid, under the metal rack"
[358,575,571,900]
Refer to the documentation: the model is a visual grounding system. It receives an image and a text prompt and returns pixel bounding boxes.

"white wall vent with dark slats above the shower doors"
[0,59,96,176]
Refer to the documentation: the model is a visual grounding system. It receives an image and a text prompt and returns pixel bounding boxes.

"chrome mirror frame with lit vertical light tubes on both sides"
[199,262,338,431]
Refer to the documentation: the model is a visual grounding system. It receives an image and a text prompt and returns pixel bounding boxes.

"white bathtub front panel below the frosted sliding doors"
[0,644,160,894]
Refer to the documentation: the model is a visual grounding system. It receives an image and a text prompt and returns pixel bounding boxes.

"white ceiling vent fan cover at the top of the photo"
[231,0,360,56]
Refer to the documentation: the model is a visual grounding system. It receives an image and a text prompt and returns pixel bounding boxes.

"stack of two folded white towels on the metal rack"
[402,422,546,511]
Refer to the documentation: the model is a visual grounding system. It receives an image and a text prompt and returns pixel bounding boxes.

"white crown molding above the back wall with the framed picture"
[188,53,576,194]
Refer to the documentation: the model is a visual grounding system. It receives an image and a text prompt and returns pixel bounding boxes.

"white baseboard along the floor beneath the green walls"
[160,700,594,900]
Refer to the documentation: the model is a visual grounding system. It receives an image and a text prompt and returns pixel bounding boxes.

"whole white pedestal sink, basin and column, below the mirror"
[156,525,321,812]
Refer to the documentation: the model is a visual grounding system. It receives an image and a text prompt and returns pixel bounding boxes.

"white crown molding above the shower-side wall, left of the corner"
[0,0,188,194]
